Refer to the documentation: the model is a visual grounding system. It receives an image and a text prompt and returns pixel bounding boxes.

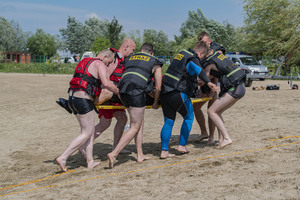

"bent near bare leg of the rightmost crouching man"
[207,93,237,148]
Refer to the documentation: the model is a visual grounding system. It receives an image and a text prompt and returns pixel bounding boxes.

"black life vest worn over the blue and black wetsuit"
[162,50,199,97]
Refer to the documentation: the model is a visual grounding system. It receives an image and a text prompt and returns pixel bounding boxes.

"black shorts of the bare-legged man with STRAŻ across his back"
[120,92,154,108]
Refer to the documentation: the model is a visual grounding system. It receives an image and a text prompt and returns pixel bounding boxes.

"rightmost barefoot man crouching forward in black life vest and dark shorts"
[198,41,246,148]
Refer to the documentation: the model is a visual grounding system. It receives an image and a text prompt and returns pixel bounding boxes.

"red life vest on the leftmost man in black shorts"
[69,58,101,97]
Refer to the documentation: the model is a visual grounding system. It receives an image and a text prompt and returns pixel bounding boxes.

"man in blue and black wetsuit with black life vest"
[160,43,216,159]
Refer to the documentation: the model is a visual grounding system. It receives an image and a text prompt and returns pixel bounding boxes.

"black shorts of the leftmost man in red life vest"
[69,96,95,115]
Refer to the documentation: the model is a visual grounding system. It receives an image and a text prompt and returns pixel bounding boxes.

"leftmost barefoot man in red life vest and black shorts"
[56,49,119,171]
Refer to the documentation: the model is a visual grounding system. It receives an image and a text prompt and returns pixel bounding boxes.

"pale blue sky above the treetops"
[0,0,244,40]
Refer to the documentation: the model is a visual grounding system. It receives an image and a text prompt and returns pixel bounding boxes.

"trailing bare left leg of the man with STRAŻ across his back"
[107,107,145,168]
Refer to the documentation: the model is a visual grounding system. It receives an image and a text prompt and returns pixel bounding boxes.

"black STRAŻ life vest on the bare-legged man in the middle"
[119,52,163,95]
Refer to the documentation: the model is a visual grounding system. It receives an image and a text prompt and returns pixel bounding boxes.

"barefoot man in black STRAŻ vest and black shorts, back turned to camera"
[107,43,163,168]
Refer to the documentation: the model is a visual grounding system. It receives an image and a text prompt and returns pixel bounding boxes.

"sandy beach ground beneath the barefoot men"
[0,73,300,200]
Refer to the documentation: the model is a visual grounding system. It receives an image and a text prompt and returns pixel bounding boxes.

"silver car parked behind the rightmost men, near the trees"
[226,54,269,80]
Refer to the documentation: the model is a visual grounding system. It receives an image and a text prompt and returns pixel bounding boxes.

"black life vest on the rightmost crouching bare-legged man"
[202,52,246,94]
